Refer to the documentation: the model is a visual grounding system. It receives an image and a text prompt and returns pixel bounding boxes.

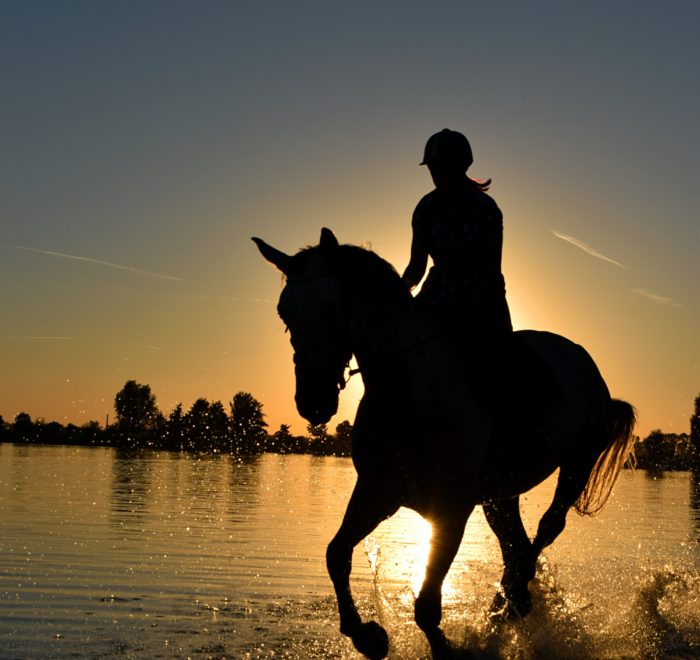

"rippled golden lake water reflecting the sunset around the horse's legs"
[0,445,700,659]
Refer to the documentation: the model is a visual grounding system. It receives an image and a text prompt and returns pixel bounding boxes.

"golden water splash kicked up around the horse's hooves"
[364,538,700,660]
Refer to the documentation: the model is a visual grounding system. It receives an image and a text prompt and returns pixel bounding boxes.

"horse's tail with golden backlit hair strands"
[574,399,637,516]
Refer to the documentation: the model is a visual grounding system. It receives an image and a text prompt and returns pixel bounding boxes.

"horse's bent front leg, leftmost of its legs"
[326,480,398,658]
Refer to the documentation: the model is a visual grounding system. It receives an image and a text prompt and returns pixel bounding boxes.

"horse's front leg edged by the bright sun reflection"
[415,505,474,657]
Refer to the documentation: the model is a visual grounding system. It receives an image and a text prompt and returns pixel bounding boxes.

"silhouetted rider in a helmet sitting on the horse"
[403,128,513,398]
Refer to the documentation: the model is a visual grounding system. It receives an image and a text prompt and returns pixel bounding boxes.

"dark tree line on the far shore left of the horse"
[0,380,352,456]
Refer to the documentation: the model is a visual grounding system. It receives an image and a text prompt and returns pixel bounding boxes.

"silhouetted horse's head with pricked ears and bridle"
[253,229,352,424]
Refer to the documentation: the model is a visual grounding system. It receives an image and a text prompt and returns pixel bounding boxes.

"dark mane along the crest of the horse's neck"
[289,245,413,305]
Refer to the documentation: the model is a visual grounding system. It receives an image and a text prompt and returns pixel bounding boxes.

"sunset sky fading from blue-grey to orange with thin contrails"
[0,0,700,436]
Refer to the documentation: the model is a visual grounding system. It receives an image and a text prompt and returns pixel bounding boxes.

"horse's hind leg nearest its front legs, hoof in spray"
[483,497,537,616]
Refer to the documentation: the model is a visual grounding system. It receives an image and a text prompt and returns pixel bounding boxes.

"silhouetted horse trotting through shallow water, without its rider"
[253,228,636,658]
